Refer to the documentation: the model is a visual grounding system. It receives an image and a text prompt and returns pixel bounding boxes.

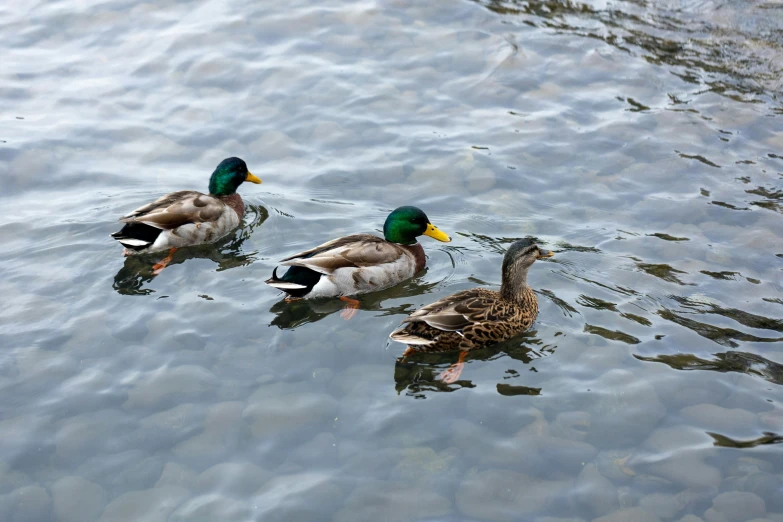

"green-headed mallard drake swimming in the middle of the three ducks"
[266,207,451,319]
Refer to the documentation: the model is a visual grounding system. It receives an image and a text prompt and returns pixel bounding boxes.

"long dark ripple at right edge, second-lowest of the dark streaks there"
[634,351,783,385]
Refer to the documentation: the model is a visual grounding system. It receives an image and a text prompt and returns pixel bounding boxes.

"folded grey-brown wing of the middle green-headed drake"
[280,234,407,274]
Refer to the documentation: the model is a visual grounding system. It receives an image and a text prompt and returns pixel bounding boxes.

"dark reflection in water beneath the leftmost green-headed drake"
[112,205,269,295]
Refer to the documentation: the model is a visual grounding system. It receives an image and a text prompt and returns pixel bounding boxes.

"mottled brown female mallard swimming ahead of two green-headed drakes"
[389,239,554,384]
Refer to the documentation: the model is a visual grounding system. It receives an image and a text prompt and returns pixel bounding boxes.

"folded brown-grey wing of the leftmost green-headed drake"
[120,190,226,230]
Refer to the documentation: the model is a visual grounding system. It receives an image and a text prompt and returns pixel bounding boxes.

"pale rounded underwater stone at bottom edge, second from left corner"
[52,476,106,522]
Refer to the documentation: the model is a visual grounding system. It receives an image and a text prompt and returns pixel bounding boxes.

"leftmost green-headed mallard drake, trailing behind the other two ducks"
[111,158,261,274]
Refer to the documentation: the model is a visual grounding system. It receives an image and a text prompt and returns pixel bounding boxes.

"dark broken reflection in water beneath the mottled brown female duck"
[394,330,557,399]
